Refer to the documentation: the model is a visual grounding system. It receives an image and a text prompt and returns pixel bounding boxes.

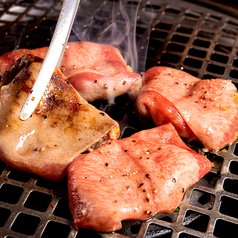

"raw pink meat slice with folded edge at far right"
[135,67,238,150]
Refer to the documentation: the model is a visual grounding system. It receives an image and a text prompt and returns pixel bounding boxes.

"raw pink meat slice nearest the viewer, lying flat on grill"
[67,123,211,232]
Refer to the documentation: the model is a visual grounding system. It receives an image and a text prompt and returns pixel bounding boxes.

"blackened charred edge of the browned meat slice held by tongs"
[0,54,43,88]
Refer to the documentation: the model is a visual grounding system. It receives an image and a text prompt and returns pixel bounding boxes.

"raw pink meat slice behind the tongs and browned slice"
[0,42,141,102]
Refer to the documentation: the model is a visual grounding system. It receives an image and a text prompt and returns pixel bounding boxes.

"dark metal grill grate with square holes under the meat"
[0,0,238,238]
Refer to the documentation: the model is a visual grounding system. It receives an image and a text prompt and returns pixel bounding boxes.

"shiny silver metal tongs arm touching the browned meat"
[19,0,80,121]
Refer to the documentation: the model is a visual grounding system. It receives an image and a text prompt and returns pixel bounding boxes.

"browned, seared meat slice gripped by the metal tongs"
[0,55,120,181]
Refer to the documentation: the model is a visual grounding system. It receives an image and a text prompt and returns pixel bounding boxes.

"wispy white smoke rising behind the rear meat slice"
[70,0,152,72]
